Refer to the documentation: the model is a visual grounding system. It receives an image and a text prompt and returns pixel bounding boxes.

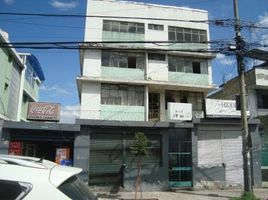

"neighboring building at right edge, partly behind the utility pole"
[209,59,268,186]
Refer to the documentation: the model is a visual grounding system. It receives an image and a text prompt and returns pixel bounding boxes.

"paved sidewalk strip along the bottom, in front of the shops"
[96,189,268,200]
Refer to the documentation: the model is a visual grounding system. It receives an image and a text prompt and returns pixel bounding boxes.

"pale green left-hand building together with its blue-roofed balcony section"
[0,31,45,121]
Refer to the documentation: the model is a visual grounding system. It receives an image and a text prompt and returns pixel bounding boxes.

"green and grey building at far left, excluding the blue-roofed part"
[0,30,25,121]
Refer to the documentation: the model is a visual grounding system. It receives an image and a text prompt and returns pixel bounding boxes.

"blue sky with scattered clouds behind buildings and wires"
[0,0,268,123]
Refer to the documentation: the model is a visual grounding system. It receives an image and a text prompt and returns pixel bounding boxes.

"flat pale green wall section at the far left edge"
[0,48,13,115]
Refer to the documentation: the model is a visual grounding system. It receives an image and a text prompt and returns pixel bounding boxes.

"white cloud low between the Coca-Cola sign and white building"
[60,105,80,124]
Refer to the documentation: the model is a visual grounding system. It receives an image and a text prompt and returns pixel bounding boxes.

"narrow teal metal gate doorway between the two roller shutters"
[168,129,193,187]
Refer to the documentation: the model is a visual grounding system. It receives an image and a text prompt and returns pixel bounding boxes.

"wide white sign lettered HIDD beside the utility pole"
[206,99,249,117]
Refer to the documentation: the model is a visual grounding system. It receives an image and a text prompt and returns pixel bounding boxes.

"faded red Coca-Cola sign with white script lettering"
[27,102,60,121]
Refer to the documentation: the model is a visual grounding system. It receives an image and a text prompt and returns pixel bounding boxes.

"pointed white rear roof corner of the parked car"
[49,165,82,187]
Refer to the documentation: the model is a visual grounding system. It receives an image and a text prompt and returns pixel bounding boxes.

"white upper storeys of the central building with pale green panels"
[77,1,213,121]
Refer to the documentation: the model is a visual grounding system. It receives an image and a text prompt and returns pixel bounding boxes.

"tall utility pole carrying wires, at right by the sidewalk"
[233,0,253,192]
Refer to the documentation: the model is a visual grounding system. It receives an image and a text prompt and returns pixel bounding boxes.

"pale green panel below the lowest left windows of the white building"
[100,104,145,121]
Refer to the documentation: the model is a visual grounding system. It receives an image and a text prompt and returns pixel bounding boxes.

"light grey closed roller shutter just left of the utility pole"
[198,130,243,185]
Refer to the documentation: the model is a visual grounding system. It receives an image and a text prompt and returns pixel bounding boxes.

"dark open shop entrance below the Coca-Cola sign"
[8,129,74,165]
